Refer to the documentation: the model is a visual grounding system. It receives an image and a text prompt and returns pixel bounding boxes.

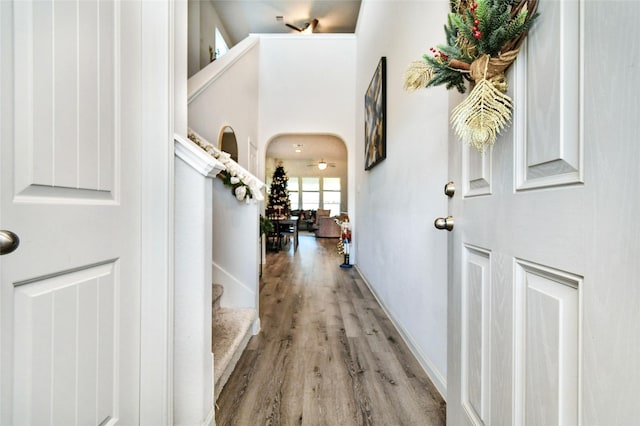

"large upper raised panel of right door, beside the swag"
[511,0,584,190]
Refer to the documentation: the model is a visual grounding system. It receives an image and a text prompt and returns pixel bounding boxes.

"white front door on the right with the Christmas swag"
[443,0,640,425]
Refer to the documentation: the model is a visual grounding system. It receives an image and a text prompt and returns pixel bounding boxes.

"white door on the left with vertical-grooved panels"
[0,0,141,425]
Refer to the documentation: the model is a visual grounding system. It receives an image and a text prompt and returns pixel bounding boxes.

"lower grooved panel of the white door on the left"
[14,262,119,425]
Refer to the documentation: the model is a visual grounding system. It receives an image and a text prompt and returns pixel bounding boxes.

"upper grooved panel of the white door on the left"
[14,1,120,198]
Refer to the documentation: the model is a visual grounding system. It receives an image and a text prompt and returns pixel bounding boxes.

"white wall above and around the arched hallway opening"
[258,34,357,240]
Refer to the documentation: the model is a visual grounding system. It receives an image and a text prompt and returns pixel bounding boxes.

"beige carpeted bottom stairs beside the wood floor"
[211,284,256,401]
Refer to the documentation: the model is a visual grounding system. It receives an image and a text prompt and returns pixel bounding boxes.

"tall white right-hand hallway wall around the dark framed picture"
[354,0,448,394]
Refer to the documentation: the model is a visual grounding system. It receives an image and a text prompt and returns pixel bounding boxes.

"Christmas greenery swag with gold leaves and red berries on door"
[404,0,538,152]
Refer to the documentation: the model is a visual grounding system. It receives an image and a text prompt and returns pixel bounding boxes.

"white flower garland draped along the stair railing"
[187,130,264,203]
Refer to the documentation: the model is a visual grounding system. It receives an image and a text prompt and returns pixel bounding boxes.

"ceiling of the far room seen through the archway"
[267,134,347,162]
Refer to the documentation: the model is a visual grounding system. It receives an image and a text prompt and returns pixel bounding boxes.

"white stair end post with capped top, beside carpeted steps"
[174,136,224,425]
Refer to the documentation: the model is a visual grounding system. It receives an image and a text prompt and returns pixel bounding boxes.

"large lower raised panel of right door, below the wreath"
[514,259,583,425]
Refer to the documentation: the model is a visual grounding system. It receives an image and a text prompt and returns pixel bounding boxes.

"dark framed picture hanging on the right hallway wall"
[364,56,387,170]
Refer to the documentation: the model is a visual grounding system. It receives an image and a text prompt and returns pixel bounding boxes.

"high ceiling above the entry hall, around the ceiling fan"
[211,0,360,45]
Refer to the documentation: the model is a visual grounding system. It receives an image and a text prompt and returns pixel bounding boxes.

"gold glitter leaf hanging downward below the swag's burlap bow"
[451,78,511,152]
